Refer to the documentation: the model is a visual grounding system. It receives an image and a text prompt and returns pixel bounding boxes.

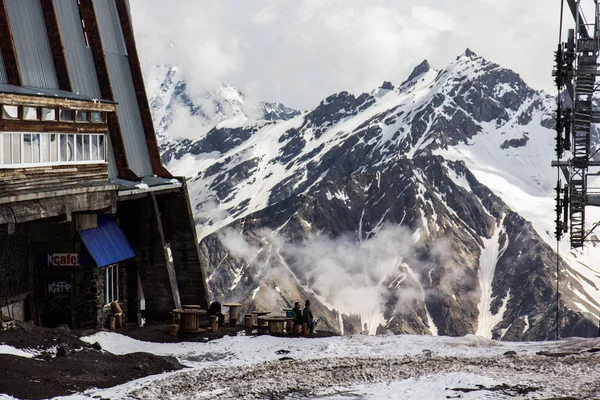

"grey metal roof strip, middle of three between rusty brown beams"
[54,0,101,99]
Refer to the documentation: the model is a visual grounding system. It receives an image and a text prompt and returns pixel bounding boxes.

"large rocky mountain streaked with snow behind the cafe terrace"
[153,50,600,340]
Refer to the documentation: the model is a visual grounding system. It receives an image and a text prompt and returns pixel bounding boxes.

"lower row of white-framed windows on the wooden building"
[0,132,106,167]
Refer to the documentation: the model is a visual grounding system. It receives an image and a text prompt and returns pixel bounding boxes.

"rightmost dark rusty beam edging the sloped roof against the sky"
[116,0,173,178]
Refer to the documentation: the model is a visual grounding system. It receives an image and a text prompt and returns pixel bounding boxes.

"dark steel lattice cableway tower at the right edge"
[552,0,600,248]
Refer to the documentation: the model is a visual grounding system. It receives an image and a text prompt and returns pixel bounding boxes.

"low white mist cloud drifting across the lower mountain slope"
[220,225,434,331]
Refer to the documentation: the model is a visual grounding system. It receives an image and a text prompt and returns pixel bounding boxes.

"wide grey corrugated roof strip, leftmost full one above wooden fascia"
[6,0,59,89]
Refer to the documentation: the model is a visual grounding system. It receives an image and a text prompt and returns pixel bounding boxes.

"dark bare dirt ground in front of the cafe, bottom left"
[0,322,332,399]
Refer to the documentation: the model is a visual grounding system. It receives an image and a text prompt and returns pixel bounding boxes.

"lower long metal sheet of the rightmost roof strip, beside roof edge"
[106,53,153,177]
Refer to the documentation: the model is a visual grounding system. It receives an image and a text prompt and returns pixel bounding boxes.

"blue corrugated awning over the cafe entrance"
[79,214,135,267]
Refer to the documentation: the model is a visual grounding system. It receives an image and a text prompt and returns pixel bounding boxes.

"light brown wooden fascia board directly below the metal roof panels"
[0,93,117,112]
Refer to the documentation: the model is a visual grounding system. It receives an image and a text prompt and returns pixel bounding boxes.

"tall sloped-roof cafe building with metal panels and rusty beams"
[0,0,207,327]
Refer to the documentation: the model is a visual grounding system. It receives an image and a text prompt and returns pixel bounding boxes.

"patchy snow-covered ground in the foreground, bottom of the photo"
[64,332,600,400]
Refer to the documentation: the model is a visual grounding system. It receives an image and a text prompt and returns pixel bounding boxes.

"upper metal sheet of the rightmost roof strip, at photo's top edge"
[93,0,127,56]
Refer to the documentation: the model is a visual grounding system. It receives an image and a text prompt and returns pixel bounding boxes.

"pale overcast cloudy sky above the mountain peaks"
[130,0,568,109]
